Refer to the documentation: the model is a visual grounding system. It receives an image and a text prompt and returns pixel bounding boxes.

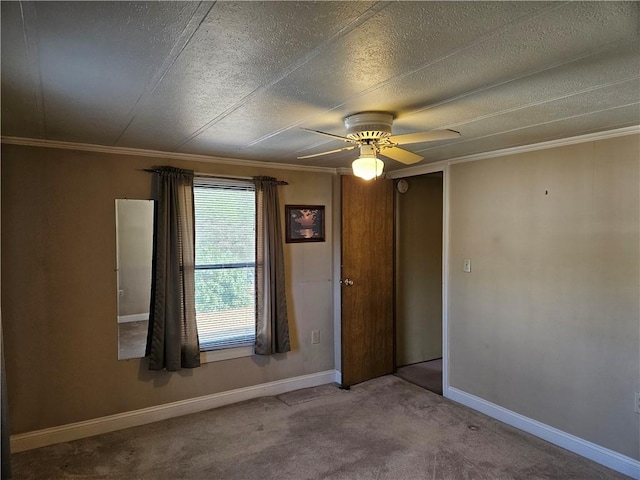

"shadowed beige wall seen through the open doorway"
[396,173,442,366]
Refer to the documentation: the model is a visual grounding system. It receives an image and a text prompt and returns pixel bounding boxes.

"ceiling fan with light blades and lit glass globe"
[298,112,460,180]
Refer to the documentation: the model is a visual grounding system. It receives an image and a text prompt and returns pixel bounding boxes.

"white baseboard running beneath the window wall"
[11,370,337,453]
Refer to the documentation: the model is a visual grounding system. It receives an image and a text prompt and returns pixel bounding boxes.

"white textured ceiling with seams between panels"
[1,1,640,170]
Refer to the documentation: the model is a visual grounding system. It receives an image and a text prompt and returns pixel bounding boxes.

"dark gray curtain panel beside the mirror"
[146,167,200,371]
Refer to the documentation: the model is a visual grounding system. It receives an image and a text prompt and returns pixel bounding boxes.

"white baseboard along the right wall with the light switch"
[447,387,640,480]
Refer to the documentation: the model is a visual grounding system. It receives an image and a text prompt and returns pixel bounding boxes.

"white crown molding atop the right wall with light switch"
[387,125,640,179]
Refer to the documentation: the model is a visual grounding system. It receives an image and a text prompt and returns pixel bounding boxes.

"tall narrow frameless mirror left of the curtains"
[116,199,153,360]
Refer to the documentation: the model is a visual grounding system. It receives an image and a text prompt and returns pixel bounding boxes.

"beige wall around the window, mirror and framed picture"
[1,145,334,434]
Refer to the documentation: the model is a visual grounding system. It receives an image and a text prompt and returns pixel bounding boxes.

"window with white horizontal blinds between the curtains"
[193,177,256,350]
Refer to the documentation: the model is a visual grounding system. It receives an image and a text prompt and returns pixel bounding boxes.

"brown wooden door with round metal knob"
[341,175,395,386]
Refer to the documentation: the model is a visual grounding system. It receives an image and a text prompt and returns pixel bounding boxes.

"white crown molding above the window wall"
[0,136,337,175]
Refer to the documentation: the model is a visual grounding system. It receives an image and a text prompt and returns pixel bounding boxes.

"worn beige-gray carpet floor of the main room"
[12,375,628,480]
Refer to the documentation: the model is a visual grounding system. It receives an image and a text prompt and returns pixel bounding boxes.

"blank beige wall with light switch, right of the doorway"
[448,135,640,459]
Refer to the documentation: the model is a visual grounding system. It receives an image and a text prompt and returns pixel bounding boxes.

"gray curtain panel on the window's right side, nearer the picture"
[254,177,291,355]
